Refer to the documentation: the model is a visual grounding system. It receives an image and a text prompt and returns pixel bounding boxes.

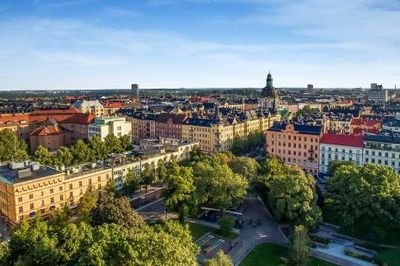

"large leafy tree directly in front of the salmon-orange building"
[255,158,321,228]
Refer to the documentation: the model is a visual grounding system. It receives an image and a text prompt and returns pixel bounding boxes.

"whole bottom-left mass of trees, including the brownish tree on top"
[0,191,199,265]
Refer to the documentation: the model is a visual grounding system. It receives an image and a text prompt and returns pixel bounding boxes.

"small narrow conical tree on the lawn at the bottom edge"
[289,225,310,266]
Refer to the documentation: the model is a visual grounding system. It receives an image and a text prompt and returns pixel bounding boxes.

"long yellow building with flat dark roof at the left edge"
[0,162,112,224]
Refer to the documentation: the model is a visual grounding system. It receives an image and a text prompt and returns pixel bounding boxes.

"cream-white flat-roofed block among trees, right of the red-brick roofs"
[88,117,132,140]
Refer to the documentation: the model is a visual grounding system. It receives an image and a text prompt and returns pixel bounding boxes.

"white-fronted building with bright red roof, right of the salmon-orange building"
[318,133,363,179]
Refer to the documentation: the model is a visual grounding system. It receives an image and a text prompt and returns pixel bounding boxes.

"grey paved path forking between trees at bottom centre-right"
[229,198,289,265]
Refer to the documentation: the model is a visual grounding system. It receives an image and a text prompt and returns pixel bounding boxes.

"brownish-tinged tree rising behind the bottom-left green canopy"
[91,192,144,228]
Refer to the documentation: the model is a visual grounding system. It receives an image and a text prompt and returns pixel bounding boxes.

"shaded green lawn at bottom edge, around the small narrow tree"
[240,244,336,266]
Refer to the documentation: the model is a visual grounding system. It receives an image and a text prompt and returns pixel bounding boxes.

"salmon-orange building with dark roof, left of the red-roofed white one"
[266,122,323,176]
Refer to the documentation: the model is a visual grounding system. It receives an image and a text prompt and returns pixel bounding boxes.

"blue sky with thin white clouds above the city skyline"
[0,0,400,90]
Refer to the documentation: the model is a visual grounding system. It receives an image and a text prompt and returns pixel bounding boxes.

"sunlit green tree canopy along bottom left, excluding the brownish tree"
[5,221,199,266]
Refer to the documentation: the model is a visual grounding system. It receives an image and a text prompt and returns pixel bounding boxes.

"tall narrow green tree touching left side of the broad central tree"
[164,166,195,221]
